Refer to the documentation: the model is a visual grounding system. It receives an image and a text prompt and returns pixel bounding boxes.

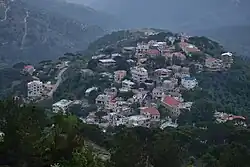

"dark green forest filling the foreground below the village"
[0,100,250,167]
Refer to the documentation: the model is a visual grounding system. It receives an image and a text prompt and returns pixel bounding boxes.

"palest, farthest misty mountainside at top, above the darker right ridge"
[85,0,250,32]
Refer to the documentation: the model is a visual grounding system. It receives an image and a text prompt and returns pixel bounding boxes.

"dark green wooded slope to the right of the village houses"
[184,57,250,120]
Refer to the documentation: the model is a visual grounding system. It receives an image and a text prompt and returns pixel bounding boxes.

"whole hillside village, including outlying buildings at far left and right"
[18,31,246,129]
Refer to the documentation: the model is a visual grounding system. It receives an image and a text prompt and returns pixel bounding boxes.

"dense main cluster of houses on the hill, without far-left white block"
[48,31,238,128]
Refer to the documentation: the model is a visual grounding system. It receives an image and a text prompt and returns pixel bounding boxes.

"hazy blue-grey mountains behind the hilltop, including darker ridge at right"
[70,0,250,56]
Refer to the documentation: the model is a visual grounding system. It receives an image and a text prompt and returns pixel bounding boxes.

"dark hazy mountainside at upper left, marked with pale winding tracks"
[0,0,118,64]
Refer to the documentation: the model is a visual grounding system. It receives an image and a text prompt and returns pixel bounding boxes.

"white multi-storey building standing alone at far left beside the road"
[27,81,43,98]
